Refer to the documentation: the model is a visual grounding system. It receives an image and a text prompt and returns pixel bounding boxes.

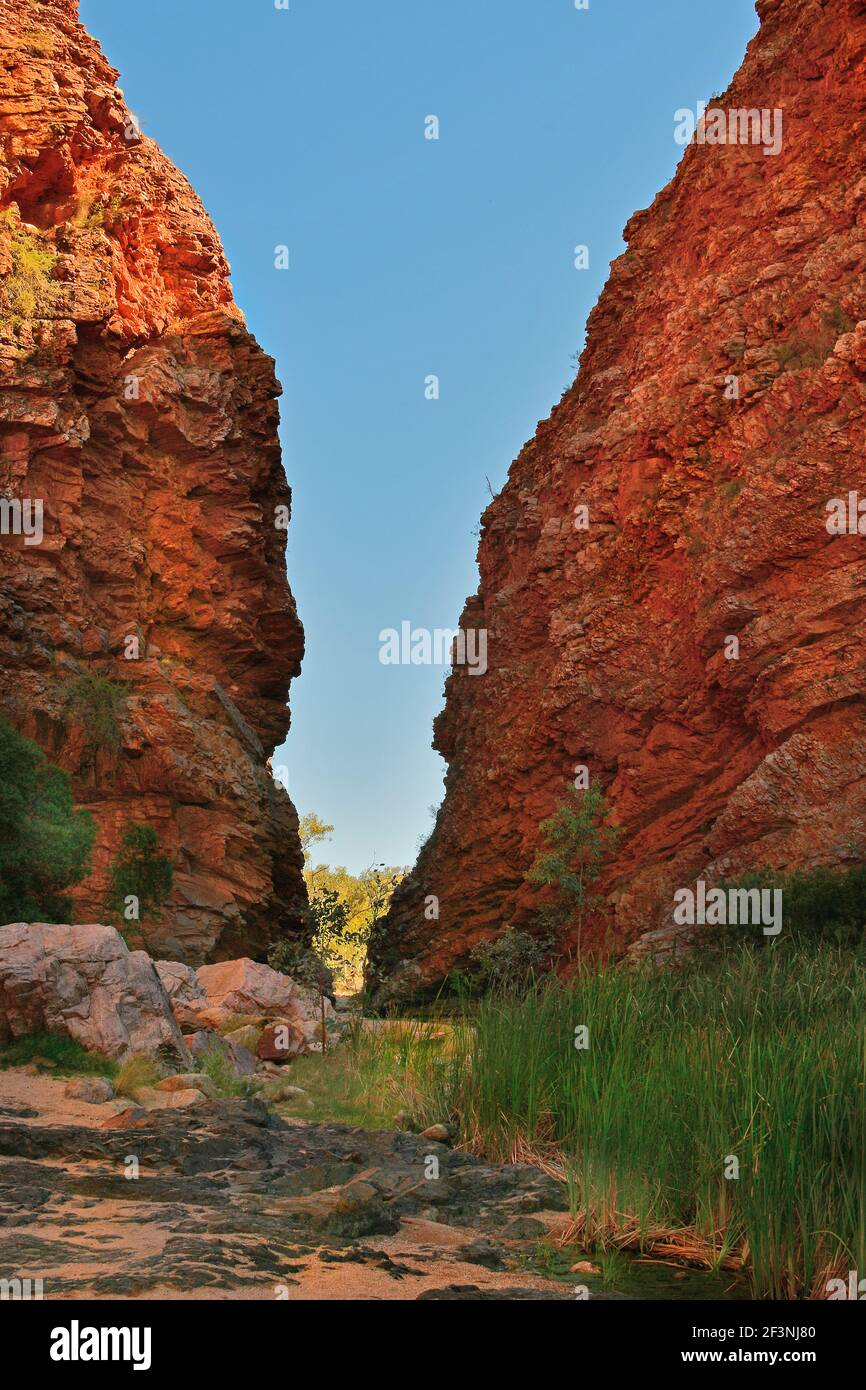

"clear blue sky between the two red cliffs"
[81,0,758,870]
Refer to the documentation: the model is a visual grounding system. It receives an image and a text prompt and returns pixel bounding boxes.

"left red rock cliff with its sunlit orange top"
[0,0,306,962]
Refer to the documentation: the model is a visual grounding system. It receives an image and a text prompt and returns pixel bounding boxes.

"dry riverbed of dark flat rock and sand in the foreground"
[0,1069,592,1301]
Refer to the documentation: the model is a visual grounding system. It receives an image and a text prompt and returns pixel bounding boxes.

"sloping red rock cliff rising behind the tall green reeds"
[374,0,866,990]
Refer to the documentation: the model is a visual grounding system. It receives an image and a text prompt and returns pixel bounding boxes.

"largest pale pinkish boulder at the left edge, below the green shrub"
[0,922,189,1066]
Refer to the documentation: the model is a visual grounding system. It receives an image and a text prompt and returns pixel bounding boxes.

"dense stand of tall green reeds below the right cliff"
[413,947,866,1297]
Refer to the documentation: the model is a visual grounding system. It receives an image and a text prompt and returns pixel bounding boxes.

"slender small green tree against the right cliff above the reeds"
[527,785,620,965]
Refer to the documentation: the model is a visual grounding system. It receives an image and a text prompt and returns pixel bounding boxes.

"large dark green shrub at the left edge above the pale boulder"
[0,716,96,923]
